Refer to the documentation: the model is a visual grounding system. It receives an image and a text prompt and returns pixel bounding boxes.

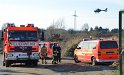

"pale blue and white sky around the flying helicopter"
[0,0,124,30]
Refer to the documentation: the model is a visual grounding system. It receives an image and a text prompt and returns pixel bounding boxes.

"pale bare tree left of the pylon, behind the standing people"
[47,19,65,40]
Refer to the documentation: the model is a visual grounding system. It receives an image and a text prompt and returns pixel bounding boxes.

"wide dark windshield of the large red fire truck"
[8,31,37,40]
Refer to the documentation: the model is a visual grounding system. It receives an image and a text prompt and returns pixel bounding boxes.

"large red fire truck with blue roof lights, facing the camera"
[2,23,39,67]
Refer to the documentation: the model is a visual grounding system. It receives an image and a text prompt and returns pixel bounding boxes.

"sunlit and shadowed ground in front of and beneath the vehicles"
[0,58,116,75]
